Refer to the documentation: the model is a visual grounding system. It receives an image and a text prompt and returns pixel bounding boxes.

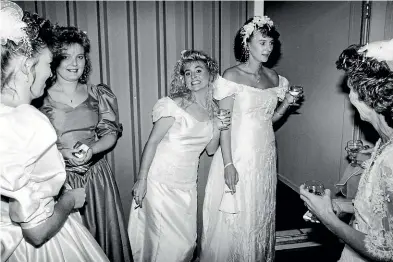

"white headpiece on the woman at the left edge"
[0,1,31,53]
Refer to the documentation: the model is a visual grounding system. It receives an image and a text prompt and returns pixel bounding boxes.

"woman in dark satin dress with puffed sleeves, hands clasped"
[40,27,132,262]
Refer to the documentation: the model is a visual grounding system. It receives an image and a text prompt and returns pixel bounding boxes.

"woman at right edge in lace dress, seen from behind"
[300,41,393,262]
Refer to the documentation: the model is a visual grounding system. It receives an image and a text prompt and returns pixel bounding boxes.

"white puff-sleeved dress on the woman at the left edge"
[0,104,109,262]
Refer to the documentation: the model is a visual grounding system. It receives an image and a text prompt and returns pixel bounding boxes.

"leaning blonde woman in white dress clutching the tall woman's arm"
[128,50,230,262]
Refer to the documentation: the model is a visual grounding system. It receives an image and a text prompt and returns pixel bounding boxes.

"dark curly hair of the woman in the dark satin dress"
[46,26,91,87]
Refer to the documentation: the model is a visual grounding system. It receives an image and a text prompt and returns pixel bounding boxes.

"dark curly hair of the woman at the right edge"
[336,45,393,127]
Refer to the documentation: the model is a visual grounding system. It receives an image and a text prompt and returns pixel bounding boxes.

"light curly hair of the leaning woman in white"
[169,50,219,118]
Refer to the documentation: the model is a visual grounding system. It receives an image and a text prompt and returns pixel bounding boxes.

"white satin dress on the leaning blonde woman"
[128,97,213,262]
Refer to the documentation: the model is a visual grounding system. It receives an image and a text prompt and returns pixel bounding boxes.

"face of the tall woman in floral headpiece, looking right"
[248,31,274,63]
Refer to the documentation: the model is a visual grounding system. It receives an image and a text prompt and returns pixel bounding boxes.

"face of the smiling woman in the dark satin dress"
[56,44,86,82]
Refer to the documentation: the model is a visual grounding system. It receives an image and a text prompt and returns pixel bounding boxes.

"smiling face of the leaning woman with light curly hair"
[184,61,210,92]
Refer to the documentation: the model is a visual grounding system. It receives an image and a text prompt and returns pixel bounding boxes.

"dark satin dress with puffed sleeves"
[40,84,132,262]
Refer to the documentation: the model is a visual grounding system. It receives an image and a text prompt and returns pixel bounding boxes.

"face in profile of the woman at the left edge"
[30,47,52,99]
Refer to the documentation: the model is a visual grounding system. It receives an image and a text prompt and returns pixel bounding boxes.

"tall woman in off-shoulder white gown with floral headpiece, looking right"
[201,17,294,262]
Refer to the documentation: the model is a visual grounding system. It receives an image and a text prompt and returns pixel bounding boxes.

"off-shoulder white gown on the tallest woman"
[201,76,288,262]
